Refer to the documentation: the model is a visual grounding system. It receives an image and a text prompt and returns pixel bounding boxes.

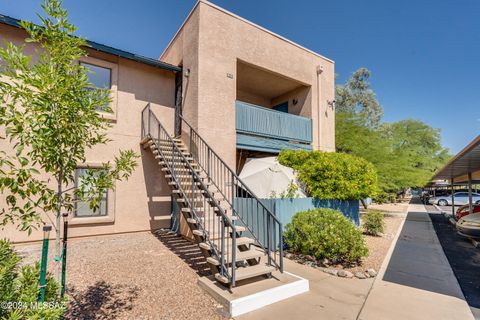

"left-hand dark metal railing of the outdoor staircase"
[141,104,237,286]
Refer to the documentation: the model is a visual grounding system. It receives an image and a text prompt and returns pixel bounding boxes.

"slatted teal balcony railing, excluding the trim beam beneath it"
[235,101,312,144]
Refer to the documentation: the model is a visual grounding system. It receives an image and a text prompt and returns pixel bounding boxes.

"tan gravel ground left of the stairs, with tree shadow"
[17,232,225,320]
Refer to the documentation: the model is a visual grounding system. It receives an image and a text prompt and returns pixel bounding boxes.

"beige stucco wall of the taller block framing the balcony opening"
[161,1,335,168]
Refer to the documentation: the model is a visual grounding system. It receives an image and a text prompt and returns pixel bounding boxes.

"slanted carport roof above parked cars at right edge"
[432,135,480,180]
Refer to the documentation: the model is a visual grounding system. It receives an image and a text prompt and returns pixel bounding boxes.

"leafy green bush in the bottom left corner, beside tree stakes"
[0,240,65,320]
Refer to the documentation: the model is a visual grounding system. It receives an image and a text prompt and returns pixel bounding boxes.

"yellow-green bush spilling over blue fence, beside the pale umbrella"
[278,150,378,200]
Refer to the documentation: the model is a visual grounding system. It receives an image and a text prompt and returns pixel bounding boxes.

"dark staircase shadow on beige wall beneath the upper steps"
[141,148,171,230]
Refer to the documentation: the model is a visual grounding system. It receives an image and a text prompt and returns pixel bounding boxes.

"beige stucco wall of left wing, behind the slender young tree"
[0,25,175,242]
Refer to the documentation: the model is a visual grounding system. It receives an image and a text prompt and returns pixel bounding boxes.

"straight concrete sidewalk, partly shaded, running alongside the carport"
[358,204,473,320]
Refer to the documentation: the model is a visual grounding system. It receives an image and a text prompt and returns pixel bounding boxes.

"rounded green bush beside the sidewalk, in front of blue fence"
[285,208,368,263]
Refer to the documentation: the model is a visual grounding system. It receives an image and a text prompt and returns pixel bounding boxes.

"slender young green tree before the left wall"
[0,0,138,276]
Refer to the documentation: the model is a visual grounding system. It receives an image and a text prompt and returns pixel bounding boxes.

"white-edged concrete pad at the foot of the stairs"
[198,271,309,317]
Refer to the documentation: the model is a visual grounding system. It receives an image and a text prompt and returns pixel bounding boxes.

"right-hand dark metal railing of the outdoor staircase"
[177,115,283,272]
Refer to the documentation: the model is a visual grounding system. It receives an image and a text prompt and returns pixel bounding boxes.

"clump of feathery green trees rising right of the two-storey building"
[335,68,450,193]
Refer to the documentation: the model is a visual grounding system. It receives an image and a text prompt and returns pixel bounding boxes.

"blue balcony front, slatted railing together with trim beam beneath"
[235,101,312,153]
